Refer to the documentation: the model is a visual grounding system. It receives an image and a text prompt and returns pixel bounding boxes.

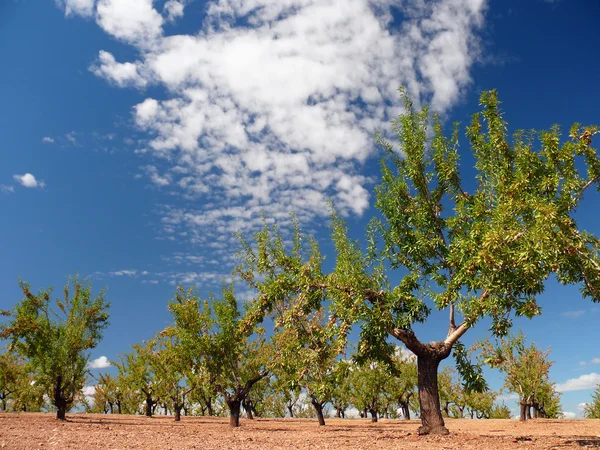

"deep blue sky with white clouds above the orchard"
[0,0,600,415]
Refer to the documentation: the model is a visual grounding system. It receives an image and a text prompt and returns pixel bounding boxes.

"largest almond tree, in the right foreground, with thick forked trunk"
[239,91,600,434]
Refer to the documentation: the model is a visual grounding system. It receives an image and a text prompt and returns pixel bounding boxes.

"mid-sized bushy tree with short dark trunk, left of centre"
[169,286,270,427]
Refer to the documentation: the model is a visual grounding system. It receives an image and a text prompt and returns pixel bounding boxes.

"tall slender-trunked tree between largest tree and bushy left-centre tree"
[237,223,347,426]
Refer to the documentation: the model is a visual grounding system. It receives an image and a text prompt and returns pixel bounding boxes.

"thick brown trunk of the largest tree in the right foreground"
[417,352,449,434]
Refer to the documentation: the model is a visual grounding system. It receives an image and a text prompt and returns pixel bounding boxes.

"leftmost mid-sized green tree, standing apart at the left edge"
[0,277,109,420]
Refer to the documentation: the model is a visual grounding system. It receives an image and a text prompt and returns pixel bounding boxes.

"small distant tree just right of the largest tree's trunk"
[477,333,561,420]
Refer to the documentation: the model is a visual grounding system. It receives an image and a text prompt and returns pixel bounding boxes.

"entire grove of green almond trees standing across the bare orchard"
[0,91,600,434]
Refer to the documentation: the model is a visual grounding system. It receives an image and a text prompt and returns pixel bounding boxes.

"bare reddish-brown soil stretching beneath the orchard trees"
[0,413,600,450]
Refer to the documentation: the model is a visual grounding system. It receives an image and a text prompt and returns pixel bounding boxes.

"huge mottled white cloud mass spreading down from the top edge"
[69,0,486,268]
